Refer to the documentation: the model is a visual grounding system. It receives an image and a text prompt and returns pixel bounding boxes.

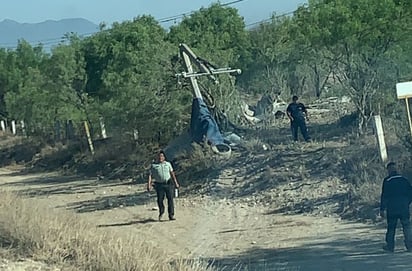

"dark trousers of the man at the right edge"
[386,212,412,250]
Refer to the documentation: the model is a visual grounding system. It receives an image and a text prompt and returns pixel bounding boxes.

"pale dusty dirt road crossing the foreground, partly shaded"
[0,168,412,271]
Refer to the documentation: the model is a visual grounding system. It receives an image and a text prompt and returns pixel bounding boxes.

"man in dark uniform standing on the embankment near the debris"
[286,95,310,142]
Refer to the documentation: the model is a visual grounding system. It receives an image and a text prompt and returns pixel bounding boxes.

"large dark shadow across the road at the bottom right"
[205,232,412,271]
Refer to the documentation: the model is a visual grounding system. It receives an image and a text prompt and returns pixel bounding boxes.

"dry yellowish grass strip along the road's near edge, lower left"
[0,192,214,271]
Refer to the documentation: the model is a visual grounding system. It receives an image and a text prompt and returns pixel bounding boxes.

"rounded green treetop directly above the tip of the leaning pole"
[169,4,249,67]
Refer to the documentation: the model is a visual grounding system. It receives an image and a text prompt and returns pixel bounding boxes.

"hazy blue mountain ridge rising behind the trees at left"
[0,18,99,50]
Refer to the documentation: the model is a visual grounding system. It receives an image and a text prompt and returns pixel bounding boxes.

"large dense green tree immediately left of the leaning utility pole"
[84,16,188,142]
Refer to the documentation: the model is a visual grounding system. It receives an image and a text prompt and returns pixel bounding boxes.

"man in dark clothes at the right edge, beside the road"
[380,162,412,252]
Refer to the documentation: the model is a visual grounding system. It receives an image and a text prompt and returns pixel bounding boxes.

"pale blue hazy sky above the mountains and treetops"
[0,0,307,24]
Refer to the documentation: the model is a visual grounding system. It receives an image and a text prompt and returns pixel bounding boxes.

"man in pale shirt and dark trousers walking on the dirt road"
[147,151,179,221]
